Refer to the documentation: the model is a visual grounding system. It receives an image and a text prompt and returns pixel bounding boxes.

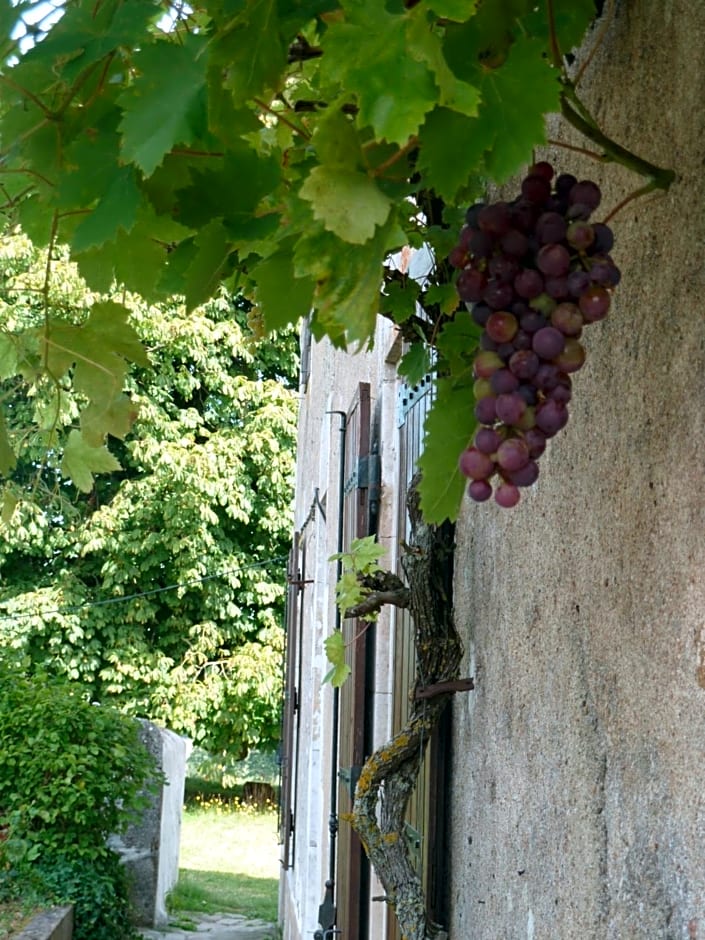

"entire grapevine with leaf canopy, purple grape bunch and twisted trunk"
[0,0,674,940]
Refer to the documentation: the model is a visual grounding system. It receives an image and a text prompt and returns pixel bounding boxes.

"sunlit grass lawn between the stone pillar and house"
[170,801,279,922]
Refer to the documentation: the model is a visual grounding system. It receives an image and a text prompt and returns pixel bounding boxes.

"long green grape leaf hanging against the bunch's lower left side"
[419,376,475,524]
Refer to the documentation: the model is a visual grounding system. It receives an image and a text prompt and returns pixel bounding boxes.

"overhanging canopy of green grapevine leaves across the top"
[0,0,594,519]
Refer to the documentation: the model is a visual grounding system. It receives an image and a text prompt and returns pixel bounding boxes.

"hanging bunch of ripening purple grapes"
[449,162,620,508]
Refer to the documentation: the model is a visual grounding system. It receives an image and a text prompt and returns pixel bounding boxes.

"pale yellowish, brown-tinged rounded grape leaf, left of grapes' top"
[300,166,391,245]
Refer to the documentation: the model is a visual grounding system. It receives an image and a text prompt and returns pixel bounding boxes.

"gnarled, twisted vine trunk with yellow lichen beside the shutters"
[351,478,472,940]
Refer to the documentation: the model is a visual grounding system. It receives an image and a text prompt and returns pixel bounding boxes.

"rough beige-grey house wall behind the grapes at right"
[450,0,705,940]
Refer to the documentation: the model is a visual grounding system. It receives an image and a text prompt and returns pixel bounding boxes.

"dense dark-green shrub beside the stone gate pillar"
[0,670,158,940]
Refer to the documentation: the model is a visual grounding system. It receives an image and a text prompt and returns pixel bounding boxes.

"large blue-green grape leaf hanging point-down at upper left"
[118,33,207,176]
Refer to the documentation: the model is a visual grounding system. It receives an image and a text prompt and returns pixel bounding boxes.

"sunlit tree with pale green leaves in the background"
[0,235,297,753]
